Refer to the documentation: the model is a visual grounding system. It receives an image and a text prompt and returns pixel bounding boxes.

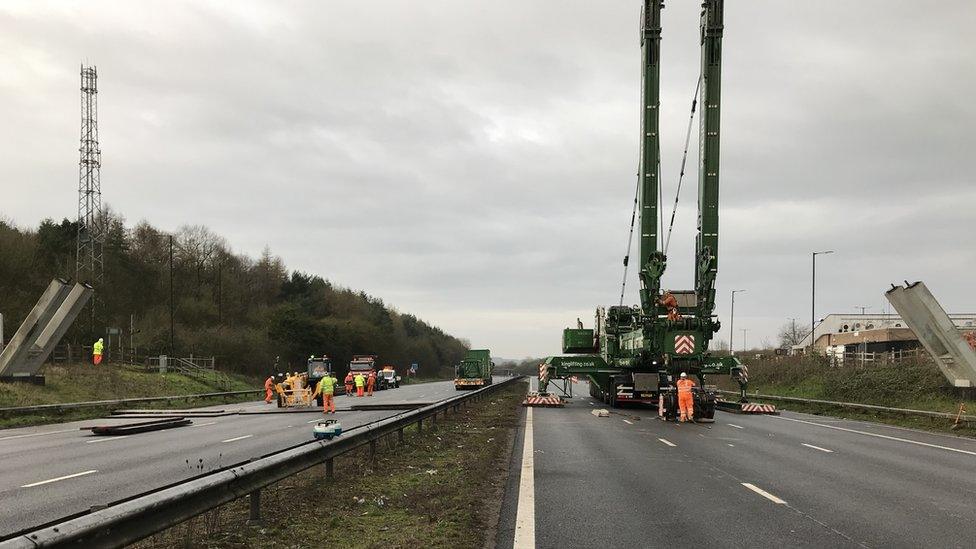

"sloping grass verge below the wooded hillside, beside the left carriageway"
[0,364,261,429]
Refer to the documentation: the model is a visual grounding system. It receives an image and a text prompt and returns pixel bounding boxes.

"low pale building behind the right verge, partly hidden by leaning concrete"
[792,314,976,353]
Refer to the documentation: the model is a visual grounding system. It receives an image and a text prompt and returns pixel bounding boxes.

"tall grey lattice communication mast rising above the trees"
[75,65,105,286]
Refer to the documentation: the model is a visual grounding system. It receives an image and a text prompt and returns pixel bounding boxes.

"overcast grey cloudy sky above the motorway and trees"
[0,0,976,358]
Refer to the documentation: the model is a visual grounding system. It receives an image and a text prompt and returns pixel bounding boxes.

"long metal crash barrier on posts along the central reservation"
[0,376,522,549]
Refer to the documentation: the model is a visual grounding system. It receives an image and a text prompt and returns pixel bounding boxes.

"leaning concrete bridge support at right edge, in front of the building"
[885,282,976,387]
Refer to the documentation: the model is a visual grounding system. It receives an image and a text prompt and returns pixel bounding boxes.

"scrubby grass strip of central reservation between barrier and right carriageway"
[136,383,525,549]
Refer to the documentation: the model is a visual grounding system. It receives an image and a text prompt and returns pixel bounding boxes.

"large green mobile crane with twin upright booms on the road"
[539,0,746,419]
